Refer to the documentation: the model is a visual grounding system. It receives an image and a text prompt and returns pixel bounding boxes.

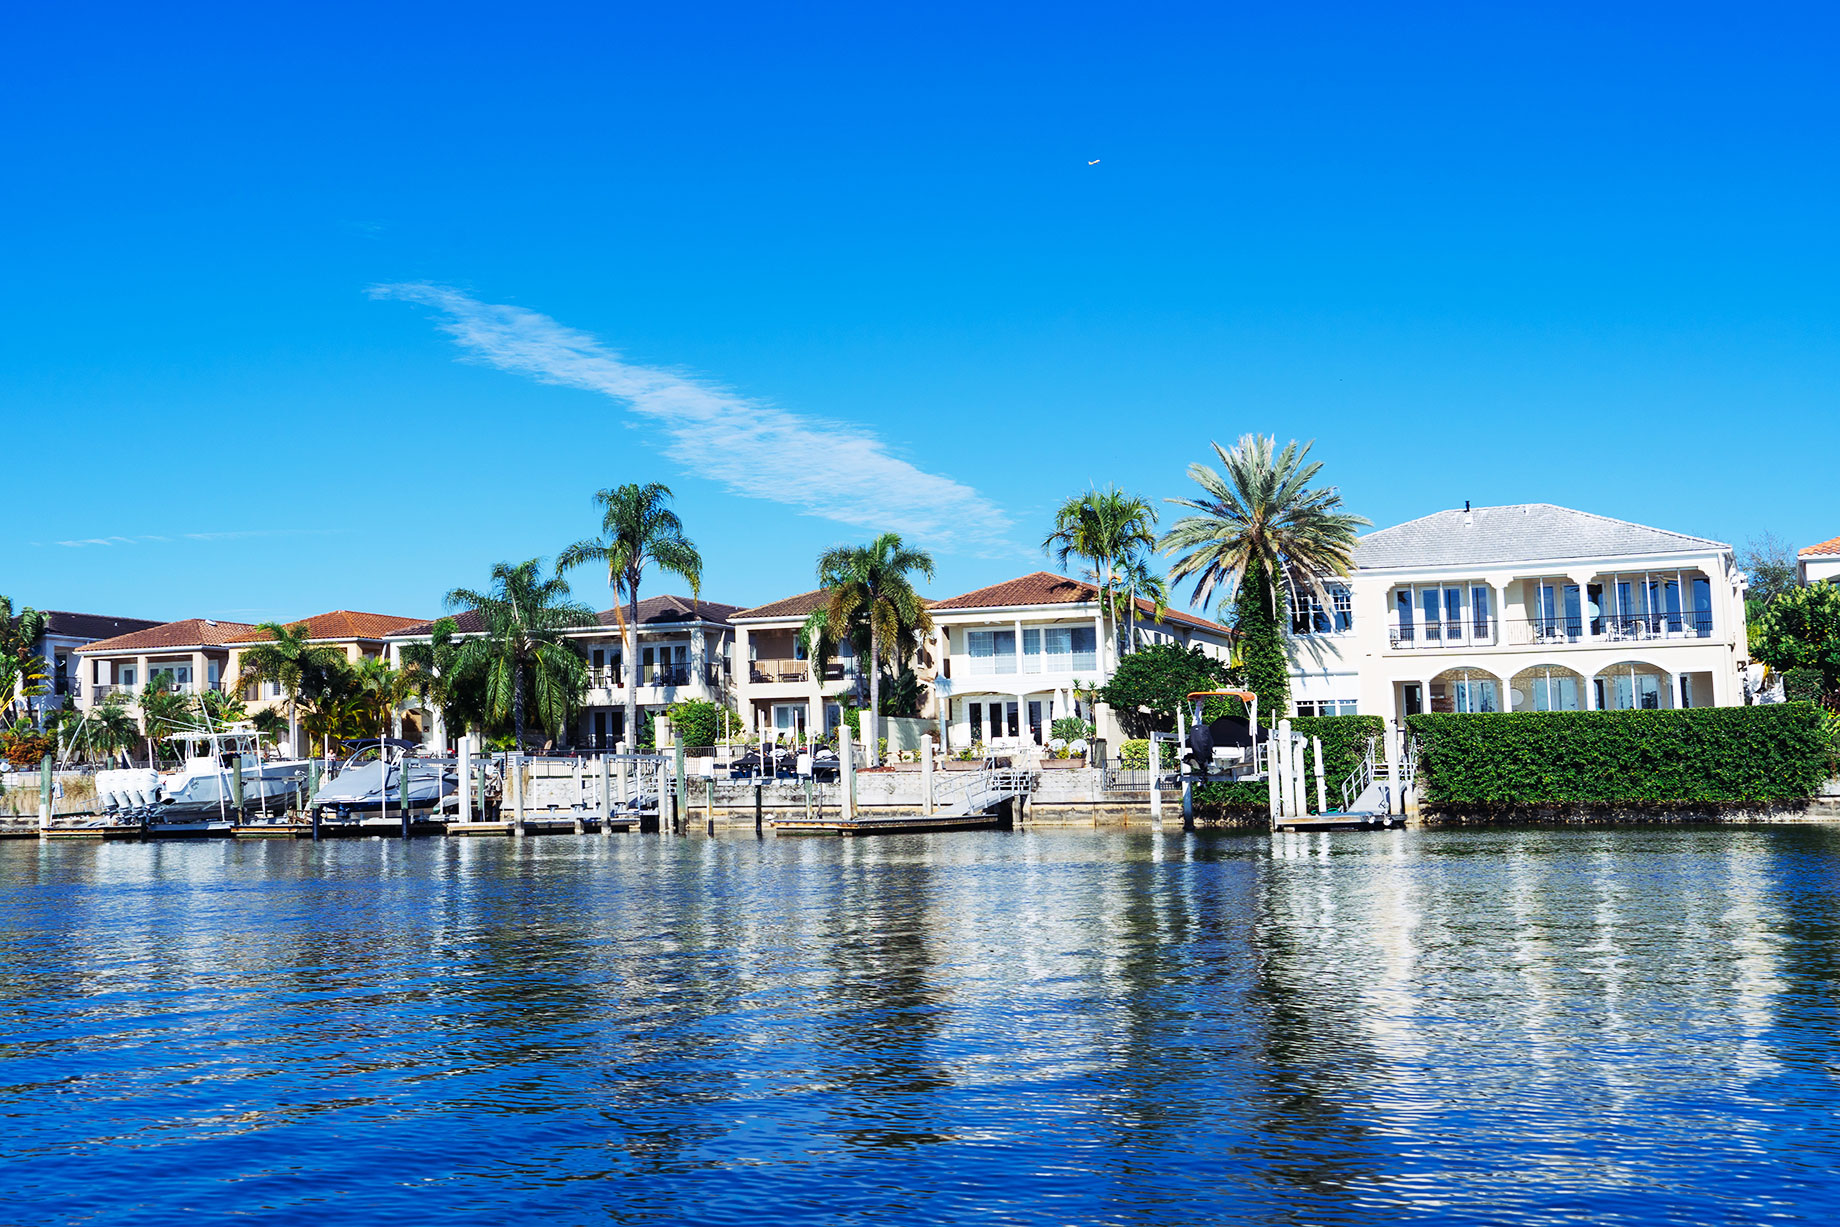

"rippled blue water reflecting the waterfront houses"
[0,830,1840,1225]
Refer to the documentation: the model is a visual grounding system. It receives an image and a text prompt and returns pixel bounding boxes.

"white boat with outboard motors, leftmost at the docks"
[96,725,309,833]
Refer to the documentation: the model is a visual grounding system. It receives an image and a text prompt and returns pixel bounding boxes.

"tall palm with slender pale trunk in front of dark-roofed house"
[556,482,703,745]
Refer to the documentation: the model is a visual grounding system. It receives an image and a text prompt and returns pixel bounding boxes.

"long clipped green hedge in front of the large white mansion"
[1406,703,1827,813]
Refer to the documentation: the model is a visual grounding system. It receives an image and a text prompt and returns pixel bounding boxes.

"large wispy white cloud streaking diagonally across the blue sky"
[370,281,1016,552]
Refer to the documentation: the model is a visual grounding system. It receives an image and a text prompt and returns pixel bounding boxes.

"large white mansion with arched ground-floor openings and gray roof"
[1290,502,1748,717]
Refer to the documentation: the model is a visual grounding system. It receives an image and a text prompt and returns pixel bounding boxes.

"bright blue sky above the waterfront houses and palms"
[0,4,1840,620]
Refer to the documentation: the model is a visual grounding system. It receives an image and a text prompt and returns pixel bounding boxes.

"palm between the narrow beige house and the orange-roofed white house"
[817,532,933,767]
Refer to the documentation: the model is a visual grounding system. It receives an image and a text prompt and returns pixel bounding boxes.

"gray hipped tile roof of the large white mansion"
[1354,502,1731,568]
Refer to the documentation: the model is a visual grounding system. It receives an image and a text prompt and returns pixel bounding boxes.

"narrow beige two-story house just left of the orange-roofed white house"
[730,589,867,741]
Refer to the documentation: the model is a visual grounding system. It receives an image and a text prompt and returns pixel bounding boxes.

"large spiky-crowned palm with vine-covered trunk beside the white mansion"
[1157,434,1369,719]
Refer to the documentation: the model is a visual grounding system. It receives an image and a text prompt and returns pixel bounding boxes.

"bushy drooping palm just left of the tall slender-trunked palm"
[447,557,598,749]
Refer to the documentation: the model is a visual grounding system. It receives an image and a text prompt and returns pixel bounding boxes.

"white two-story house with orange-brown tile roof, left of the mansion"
[931,570,1231,747]
